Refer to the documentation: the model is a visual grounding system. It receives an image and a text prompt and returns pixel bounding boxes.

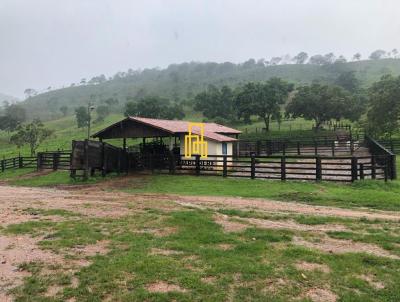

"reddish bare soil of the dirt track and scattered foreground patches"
[0,183,400,301]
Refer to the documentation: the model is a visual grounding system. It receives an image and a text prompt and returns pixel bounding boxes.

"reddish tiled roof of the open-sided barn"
[93,116,241,142]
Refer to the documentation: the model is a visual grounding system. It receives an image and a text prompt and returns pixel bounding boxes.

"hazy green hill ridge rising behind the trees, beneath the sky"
[22,59,400,120]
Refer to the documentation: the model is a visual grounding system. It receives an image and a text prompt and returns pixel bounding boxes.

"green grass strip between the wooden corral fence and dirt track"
[124,171,400,211]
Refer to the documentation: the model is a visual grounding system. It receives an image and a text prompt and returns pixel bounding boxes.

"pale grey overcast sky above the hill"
[0,0,400,97]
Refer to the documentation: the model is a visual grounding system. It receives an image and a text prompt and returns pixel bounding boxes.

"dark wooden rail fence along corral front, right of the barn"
[150,154,395,182]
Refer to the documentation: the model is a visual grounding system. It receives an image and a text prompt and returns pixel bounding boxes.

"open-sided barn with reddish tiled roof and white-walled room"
[92,116,241,156]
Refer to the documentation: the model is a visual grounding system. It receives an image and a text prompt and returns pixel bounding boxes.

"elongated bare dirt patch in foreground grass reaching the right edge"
[293,236,400,259]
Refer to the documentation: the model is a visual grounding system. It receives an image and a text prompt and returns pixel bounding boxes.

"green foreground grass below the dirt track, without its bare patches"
[3,209,400,301]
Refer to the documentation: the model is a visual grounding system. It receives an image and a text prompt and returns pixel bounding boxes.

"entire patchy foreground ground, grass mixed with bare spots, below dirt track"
[1,182,400,301]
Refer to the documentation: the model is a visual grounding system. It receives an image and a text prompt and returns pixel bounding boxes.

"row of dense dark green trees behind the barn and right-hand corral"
[194,72,366,131]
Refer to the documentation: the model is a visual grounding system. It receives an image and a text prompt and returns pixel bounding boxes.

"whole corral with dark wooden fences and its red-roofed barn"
[2,117,396,182]
